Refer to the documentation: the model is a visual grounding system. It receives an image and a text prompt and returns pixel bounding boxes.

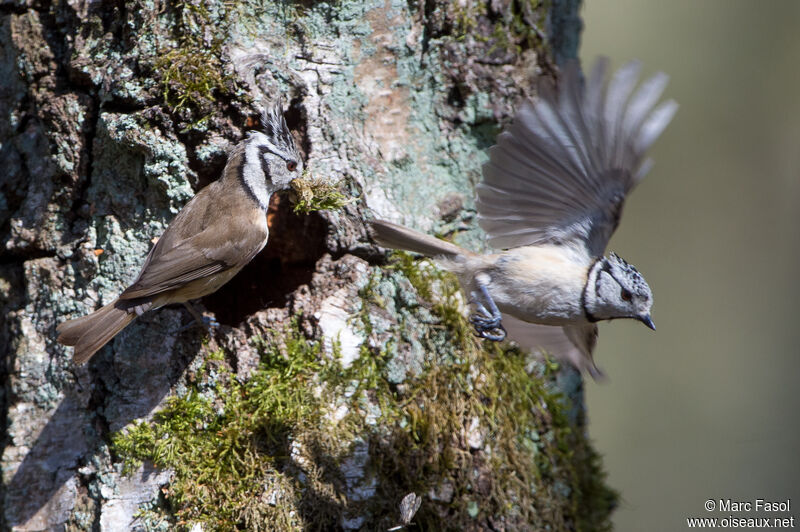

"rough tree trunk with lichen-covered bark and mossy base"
[0,0,613,530]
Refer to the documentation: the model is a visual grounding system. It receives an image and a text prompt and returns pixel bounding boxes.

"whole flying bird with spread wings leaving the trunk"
[371,59,677,378]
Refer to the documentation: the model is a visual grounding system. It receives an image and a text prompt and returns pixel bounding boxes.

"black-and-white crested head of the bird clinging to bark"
[243,102,303,208]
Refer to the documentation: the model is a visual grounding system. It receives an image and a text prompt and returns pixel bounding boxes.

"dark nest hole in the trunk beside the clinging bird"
[203,194,327,327]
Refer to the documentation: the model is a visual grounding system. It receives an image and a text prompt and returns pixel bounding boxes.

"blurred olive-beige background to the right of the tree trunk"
[581,0,800,532]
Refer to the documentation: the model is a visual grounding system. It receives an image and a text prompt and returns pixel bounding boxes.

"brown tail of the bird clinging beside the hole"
[56,299,136,364]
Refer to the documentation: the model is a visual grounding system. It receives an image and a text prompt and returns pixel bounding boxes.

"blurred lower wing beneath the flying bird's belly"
[502,313,603,380]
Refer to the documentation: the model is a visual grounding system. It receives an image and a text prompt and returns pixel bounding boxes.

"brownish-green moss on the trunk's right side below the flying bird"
[362,253,616,530]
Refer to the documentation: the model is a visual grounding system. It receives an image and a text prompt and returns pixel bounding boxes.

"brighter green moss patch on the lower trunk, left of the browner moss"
[113,330,348,530]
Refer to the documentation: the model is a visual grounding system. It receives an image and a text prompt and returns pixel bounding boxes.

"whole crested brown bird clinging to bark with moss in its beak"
[57,105,303,364]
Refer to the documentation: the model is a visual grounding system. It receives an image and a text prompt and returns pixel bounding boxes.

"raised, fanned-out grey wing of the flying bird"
[476,59,677,256]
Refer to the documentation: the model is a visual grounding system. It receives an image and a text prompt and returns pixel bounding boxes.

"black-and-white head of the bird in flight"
[584,253,655,330]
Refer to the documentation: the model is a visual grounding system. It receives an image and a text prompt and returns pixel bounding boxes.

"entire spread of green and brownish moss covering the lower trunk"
[113,254,615,530]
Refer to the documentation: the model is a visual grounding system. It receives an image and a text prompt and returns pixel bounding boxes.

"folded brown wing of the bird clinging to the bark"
[119,202,267,299]
